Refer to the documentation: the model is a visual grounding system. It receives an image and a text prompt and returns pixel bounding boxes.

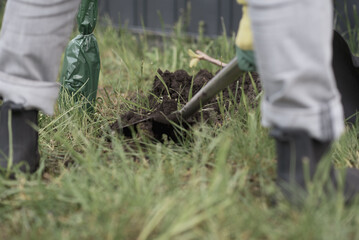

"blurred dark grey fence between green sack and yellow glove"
[99,0,241,36]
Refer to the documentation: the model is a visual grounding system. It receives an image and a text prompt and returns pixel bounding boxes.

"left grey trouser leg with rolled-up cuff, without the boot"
[0,0,80,114]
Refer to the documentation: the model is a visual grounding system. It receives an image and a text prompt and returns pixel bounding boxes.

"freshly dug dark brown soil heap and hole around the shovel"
[111,69,262,141]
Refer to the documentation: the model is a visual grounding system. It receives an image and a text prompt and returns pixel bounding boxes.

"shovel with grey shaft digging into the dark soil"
[120,58,243,135]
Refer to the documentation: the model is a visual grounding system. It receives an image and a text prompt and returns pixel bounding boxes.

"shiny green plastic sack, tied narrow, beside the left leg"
[60,0,100,110]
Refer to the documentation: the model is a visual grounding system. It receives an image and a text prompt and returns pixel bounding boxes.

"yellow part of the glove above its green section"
[236,0,253,51]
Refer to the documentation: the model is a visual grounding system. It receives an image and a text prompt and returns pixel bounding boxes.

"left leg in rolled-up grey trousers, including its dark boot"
[0,0,80,172]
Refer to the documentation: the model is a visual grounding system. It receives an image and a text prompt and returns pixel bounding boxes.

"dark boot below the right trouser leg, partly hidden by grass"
[271,129,359,204]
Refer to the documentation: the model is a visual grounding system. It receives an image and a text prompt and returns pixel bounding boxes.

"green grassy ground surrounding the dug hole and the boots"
[0,12,359,240]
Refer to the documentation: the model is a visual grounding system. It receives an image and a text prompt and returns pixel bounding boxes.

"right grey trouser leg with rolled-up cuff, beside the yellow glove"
[248,0,344,140]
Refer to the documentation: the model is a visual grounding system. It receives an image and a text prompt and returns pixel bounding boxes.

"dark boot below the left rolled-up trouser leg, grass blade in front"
[0,101,40,173]
